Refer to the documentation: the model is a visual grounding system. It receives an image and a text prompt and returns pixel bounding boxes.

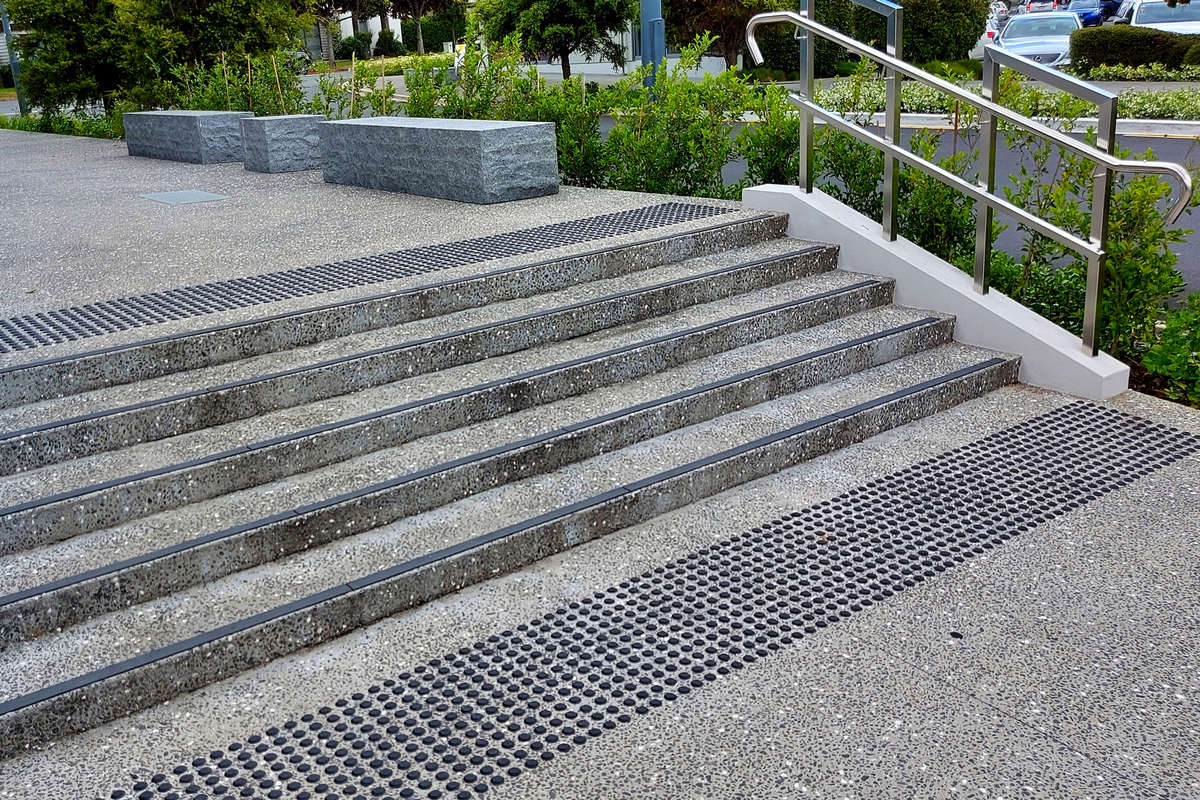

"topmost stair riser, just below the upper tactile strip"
[0,216,787,408]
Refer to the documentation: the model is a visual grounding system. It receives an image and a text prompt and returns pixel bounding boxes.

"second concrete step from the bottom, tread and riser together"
[0,299,936,644]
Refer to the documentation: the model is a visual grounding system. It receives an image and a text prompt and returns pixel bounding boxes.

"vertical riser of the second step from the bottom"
[0,309,953,642]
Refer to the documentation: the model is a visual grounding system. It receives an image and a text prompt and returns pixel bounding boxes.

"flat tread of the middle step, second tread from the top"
[0,270,870,509]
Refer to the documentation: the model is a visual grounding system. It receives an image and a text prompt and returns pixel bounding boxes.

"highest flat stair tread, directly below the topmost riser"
[0,239,809,435]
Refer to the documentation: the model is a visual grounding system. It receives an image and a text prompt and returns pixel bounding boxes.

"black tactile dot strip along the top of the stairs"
[0,203,733,353]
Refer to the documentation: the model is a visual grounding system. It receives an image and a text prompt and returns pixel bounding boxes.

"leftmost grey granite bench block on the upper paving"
[125,112,253,164]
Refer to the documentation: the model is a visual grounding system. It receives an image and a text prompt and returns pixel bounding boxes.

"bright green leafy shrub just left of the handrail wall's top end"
[606,36,749,197]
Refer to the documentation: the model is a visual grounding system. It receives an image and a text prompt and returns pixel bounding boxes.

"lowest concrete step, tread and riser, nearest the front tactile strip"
[0,344,1016,754]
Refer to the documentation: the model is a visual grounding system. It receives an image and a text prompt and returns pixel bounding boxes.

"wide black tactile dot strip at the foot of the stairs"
[110,402,1200,800]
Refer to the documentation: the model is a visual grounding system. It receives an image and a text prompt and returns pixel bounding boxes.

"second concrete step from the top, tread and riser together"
[0,241,833,474]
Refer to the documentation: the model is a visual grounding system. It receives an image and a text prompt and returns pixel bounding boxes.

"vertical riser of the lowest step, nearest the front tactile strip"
[0,360,1018,757]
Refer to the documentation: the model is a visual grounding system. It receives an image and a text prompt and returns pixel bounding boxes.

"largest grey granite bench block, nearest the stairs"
[318,116,558,203]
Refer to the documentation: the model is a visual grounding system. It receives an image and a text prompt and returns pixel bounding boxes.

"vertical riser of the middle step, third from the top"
[0,272,890,555]
